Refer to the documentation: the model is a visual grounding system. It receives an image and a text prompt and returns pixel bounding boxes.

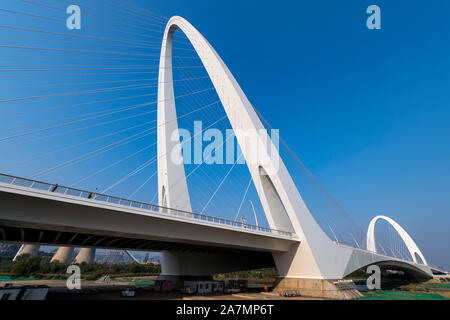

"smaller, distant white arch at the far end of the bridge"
[367,216,428,265]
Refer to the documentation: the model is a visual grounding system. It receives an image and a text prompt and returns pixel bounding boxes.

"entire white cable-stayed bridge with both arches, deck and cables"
[0,5,442,297]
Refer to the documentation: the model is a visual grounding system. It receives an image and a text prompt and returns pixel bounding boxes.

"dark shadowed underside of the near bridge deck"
[0,221,275,275]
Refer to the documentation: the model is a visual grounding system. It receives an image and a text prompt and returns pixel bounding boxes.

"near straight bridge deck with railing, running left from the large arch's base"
[0,175,299,252]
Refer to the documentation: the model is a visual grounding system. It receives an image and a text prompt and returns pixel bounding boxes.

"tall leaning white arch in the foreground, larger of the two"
[158,16,350,278]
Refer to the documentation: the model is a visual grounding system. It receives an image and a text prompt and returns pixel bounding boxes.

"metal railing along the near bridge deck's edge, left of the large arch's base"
[0,173,293,237]
